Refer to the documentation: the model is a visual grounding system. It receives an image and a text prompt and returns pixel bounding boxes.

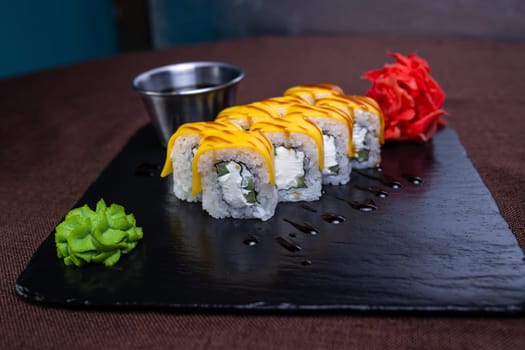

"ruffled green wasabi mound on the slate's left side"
[55,199,142,267]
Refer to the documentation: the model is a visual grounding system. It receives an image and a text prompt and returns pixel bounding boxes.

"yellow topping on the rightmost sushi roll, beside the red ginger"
[316,96,385,144]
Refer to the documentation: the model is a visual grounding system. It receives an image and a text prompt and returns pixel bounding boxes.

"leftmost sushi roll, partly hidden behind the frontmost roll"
[161,121,242,202]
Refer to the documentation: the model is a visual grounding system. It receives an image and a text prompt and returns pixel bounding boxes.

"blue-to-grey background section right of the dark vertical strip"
[150,0,525,47]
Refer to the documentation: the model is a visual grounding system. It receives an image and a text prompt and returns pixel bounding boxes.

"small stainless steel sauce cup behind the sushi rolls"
[132,61,244,146]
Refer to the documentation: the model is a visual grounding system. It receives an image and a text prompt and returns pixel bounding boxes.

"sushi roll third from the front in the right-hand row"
[284,104,354,185]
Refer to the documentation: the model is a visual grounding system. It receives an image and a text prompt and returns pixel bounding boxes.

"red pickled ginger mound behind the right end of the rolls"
[363,52,446,142]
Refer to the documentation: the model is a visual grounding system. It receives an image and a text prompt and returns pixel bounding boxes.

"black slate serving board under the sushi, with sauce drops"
[16,126,525,313]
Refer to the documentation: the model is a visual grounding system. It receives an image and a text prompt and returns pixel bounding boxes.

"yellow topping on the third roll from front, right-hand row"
[284,104,355,157]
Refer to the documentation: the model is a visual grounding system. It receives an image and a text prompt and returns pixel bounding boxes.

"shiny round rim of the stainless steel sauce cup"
[131,61,245,96]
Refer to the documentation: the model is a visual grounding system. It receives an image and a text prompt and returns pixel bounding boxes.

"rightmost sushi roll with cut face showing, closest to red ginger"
[316,96,384,169]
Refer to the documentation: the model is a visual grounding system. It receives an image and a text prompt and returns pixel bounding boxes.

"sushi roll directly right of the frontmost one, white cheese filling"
[251,117,323,202]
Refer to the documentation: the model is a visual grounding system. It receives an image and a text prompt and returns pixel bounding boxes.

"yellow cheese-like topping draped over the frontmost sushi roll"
[191,130,275,196]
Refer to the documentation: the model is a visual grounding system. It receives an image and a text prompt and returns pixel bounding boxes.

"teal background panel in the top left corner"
[0,0,118,78]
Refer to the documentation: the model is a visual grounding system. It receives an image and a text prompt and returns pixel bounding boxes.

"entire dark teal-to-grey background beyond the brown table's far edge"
[0,0,525,78]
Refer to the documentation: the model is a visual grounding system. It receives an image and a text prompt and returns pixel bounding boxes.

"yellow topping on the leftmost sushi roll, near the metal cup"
[160,121,241,177]
